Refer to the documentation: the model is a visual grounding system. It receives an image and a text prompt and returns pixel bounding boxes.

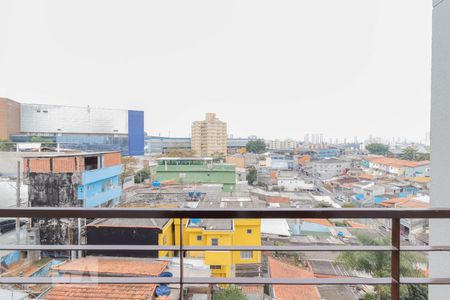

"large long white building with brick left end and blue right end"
[0,99,144,155]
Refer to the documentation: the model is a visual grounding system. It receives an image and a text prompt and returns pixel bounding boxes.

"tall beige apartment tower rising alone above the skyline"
[191,113,227,156]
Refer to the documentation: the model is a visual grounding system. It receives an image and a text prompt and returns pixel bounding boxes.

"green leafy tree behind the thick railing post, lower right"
[335,235,428,300]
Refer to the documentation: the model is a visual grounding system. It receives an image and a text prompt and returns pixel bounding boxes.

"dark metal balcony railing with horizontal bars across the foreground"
[0,208,450,300]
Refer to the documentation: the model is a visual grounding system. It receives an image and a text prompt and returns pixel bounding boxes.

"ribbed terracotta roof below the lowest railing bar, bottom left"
[42,284,156,300]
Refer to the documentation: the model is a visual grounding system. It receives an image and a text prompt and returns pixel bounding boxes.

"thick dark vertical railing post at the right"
[391,218,400,300]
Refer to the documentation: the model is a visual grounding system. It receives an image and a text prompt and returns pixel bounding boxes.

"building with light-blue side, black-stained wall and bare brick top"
[24,152,122,207]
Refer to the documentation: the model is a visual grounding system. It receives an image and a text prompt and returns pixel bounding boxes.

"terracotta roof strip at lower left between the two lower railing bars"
[53,257,169,276]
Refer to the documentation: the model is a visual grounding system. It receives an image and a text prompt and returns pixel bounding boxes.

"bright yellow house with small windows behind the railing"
[174,219,261,277]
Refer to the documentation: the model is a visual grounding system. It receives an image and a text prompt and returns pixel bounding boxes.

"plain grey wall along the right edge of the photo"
[429,0,450,300]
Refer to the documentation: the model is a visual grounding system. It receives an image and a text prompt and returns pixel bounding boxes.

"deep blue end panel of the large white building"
[128,110,144,156]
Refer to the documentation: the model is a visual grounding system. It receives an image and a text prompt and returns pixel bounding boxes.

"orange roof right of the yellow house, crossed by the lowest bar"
[269,257,320,300]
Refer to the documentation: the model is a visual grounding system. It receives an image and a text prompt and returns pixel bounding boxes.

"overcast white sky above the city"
[0,0,432,140]
